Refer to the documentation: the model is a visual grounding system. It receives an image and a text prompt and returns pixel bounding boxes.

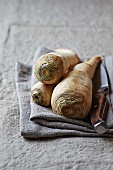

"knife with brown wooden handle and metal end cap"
[90,60,109,134]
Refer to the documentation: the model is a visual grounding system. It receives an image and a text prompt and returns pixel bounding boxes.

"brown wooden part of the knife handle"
[90,90,106,125]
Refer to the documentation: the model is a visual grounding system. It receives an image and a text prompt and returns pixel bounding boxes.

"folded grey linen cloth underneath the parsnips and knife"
[16,47,113,138]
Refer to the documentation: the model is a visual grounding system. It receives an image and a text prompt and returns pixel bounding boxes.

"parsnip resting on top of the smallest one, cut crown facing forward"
[34,49,79,84]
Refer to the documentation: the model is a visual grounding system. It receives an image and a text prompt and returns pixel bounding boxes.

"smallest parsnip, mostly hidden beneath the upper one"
[31,82,55,106]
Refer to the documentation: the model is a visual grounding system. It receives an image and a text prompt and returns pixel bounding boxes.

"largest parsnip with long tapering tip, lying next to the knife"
[51,56,101,119]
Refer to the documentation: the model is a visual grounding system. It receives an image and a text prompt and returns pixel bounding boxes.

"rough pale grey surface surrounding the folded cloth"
[0,0,113,170]
